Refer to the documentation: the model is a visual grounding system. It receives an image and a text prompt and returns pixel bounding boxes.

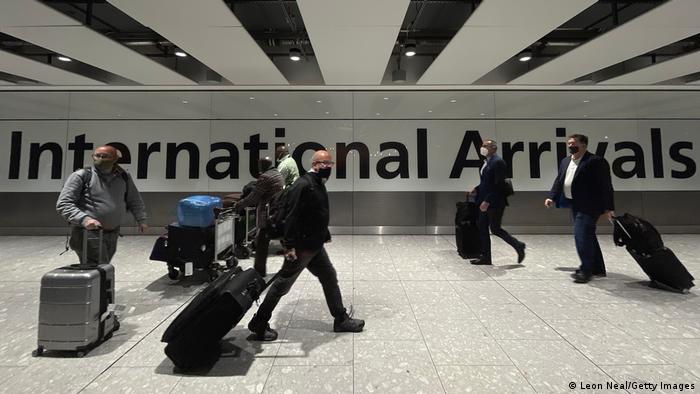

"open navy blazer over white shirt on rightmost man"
[549,152,615,216]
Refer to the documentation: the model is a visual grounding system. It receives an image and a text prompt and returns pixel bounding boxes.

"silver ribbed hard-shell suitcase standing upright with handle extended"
[32,230,119,357]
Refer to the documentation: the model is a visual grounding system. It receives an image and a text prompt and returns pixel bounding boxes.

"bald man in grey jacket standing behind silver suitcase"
[56,146,148,265]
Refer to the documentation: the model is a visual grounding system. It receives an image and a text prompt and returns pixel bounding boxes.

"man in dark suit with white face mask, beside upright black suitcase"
[471,140,525,265]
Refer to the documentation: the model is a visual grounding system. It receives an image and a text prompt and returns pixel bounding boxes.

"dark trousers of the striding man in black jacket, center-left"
[256,247,345,322]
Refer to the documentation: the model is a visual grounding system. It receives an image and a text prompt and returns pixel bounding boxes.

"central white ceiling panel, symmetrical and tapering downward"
[297,0,410,85]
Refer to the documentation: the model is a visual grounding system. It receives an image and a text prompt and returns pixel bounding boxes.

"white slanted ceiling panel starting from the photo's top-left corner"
[0,0,194,85]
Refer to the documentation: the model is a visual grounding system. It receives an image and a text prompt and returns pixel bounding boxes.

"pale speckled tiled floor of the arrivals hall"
[0,235,700,393]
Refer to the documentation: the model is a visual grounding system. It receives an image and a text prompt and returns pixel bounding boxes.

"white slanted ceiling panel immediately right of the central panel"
[418,0,595,85]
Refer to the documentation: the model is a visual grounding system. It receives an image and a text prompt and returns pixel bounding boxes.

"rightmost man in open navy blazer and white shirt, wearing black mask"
[544,134,615,283]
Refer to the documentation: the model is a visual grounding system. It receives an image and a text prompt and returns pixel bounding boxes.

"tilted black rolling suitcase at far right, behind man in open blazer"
[612,213,695,293]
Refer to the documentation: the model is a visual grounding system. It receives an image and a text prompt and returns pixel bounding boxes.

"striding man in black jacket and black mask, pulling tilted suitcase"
[248,150,365,341]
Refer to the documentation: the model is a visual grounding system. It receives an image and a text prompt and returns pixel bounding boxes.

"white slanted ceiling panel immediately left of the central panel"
[109,0,288,85]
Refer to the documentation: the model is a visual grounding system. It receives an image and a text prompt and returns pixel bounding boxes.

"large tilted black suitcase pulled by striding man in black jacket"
[161,268,277,371]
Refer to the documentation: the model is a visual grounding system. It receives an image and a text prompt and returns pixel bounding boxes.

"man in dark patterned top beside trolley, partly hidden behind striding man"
[233,157,284,276]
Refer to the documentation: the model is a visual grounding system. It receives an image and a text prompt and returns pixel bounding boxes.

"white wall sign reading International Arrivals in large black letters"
[0,92,700,192]
